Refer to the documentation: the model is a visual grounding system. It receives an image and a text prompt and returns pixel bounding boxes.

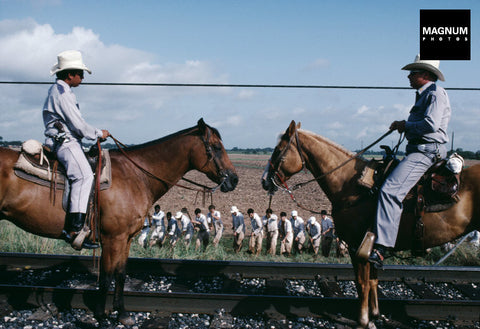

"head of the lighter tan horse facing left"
[262,120,305,194]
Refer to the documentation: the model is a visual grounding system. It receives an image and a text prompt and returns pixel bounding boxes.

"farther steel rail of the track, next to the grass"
[0,253,480,283]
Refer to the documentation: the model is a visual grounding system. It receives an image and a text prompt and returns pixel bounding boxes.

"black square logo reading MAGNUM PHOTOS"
[420,9,470,60]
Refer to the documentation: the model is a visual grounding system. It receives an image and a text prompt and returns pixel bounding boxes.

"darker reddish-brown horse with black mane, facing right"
[0,119,238,324]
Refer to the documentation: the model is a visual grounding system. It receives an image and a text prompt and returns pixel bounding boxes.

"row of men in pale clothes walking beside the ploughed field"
[138,204,345,257]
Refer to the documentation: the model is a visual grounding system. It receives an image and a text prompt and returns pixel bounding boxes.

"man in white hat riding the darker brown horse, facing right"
[43,50,110,249]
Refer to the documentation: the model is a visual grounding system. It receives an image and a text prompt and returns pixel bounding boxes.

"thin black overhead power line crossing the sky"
[0,81,480,91]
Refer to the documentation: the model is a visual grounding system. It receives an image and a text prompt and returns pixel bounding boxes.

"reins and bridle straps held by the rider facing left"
[268,129,403,214]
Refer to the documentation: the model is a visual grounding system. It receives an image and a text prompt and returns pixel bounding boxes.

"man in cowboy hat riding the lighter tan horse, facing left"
[368,55,451,268]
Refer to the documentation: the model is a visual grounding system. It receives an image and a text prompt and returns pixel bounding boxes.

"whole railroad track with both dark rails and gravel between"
[0,253,480,323]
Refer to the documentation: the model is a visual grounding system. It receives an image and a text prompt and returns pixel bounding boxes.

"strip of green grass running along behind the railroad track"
[0,220,480,266]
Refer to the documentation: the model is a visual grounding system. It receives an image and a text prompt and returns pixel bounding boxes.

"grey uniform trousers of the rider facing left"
[375,143,446,247]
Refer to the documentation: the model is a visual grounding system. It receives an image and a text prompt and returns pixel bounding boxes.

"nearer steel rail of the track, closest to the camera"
[0,285,480,322]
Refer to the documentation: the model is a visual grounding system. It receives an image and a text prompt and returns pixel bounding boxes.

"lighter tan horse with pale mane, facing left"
[262,121,480,327]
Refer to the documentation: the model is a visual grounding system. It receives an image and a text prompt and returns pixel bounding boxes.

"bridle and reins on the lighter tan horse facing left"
[267,129,396,214]
